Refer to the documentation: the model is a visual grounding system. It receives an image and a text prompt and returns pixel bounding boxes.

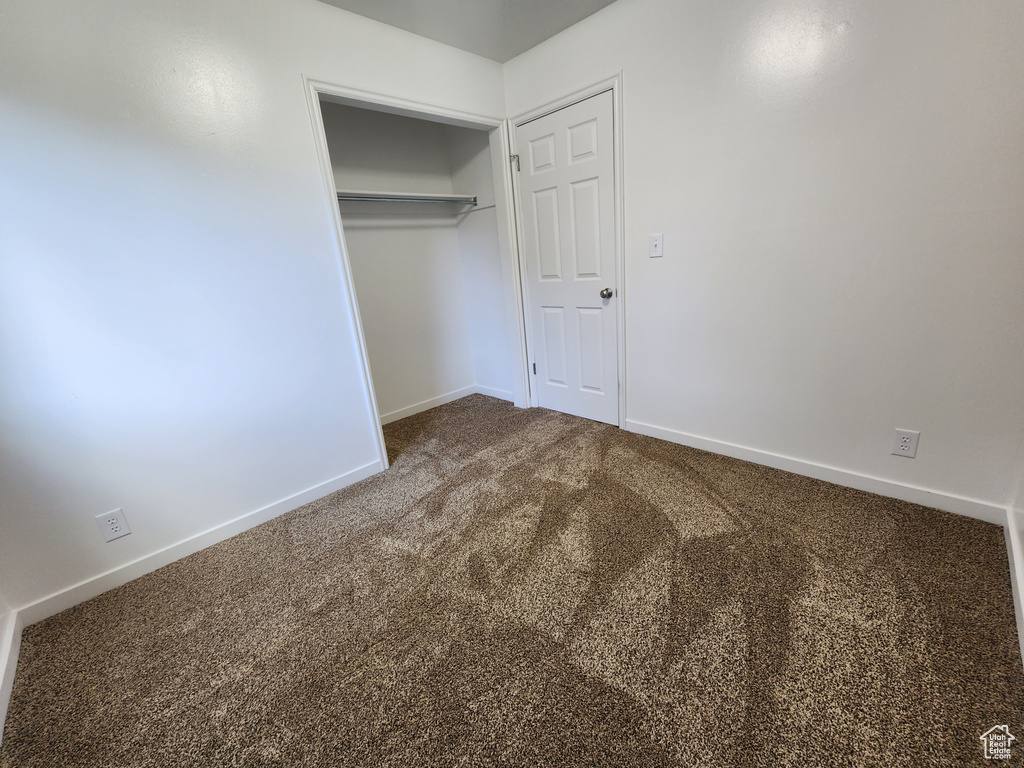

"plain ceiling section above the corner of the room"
[313,0,613,62]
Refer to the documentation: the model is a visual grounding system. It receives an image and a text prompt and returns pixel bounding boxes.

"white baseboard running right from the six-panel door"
[626,419,1007,525]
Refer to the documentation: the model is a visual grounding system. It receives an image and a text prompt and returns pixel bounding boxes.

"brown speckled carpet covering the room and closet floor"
[0,395,1024,768]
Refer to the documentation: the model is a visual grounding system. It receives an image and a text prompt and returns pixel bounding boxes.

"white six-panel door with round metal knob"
[516,91,618,425]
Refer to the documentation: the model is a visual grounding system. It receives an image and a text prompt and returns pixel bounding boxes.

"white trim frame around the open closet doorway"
[302,75,534,471]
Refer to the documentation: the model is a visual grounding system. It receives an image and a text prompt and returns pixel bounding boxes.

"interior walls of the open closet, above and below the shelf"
[321,101,513,423]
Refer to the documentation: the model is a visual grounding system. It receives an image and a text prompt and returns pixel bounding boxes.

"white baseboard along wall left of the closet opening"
[18,461,381,627]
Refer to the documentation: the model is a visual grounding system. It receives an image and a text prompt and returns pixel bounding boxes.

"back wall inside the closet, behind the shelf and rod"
[322,103,473,420]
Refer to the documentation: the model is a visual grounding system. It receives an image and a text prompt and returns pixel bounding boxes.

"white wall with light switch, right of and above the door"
[505,0,1024,508]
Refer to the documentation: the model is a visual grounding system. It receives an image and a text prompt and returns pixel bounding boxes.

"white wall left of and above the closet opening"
[0,0,503,607]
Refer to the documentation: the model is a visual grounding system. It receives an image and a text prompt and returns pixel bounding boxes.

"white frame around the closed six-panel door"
[508,72,626,429]
